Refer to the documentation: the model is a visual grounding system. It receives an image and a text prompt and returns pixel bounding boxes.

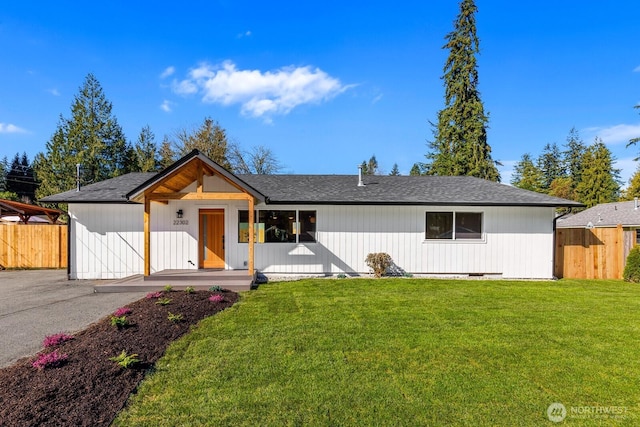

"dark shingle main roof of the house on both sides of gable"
[42,173,583,207]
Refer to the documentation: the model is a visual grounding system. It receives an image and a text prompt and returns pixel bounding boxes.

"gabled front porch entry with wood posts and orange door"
[126,150,265,280]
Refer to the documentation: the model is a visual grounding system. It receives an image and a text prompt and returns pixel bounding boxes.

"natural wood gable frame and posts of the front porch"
[127,150,265,276]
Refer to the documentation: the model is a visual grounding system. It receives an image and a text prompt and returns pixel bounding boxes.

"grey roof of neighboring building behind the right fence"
[556,201,640,228]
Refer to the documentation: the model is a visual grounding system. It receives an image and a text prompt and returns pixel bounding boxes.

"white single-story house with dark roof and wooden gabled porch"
[42,151,582,279]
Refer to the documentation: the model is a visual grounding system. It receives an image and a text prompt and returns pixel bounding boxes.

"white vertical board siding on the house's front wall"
[69,201,554,279]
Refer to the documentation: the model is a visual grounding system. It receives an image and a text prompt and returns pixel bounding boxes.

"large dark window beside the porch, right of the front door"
[238,210,316,243]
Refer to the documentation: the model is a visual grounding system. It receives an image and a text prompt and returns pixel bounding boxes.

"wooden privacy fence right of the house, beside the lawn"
[555,225,635,279]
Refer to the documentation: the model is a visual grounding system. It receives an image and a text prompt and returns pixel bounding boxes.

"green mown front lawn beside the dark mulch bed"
[116,279,640,426]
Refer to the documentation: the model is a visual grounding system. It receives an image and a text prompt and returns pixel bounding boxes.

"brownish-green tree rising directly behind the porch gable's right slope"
[176,117,231,170]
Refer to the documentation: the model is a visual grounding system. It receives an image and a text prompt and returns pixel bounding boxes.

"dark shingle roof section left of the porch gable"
[40,172,156,203]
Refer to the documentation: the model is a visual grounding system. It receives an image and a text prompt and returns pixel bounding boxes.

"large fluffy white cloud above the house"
[173,61,352,121]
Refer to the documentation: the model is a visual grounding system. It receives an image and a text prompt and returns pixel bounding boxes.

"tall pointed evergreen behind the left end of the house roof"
[34,74,129,197]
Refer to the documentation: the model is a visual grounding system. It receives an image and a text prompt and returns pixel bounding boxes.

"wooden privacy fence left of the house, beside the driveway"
[0,224,67,268]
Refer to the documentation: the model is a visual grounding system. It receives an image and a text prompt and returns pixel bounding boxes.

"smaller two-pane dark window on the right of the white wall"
[425,212,482,240]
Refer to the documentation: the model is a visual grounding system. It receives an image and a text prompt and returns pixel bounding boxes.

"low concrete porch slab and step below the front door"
[94,269,257,292]
